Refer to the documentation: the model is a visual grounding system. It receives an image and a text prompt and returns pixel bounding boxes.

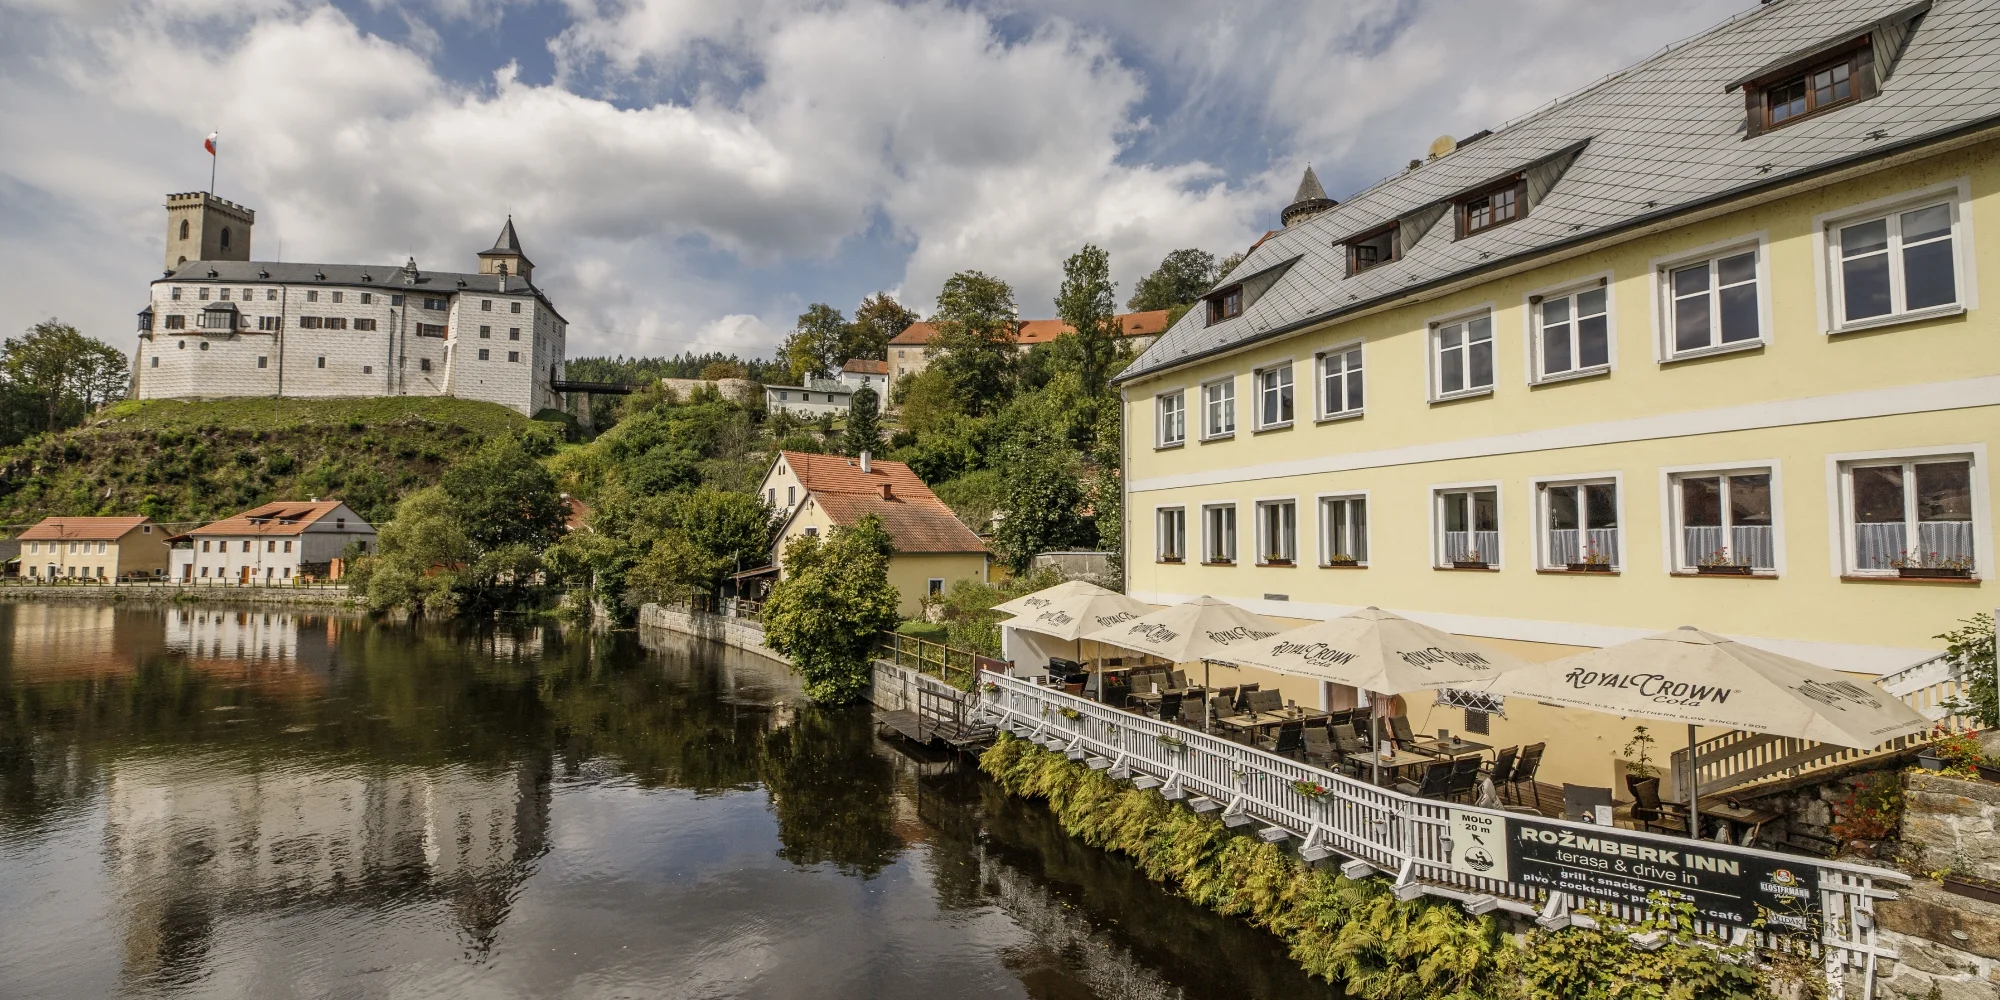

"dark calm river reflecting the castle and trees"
[0,602,1336,1000]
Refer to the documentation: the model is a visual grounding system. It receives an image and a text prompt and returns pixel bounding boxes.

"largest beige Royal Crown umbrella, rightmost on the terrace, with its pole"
[1490,626,1930,836]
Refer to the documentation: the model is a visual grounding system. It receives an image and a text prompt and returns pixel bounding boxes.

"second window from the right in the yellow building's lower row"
[1668,466,1778,574]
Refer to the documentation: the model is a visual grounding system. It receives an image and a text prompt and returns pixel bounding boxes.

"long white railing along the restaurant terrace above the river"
[984,664,1908,996]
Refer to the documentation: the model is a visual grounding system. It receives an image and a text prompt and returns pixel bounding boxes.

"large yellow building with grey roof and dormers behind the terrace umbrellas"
[1120,0,2000,794]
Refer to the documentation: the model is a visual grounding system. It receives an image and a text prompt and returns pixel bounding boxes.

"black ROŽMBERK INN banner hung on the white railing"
[1504,810,1820,932]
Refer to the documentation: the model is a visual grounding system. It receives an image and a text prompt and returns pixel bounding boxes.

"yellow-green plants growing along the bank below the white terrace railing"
[980,734,1824,1000]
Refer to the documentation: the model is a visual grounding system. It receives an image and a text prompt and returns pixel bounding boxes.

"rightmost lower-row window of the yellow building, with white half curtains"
[1840,454,1980,576]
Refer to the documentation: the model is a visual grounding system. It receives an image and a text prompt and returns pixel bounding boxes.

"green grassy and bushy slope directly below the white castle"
[0,396,560,534]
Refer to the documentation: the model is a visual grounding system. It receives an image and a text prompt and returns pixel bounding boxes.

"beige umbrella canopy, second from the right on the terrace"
[1236,608,1528,694]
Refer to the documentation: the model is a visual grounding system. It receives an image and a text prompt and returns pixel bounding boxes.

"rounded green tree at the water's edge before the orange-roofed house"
[764,514,900,704]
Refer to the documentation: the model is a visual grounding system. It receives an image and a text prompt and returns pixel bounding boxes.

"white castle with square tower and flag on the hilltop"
[132,192,568,416]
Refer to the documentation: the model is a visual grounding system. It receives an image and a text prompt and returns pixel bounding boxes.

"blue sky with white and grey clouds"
[0,0,1754,358]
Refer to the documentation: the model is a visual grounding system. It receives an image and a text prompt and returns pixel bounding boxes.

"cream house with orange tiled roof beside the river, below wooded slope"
[760,452,990,618]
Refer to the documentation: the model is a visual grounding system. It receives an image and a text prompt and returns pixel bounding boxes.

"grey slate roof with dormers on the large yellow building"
[1118,0,2000,382]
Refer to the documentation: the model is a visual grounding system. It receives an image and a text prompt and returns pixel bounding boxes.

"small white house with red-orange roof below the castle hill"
[168,500,376,584]
